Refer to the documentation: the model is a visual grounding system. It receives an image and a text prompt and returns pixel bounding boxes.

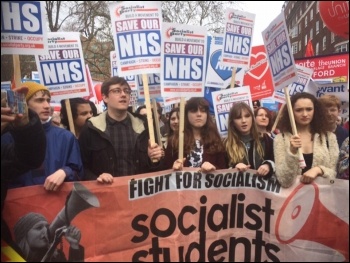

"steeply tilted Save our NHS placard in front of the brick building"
[262,12,298,90]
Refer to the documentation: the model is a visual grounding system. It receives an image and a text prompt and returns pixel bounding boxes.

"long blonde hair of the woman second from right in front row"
[224,102,264,163]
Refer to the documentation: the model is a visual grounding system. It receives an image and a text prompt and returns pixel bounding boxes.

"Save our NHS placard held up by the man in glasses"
[109,1,162,76]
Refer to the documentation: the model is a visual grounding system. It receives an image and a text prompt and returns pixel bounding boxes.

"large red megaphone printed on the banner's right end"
[275,183,349,262]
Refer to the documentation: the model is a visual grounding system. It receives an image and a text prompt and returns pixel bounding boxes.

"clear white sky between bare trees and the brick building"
[240,1,284,46]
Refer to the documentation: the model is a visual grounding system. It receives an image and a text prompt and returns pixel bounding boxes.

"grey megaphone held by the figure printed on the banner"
[49,182,100,240]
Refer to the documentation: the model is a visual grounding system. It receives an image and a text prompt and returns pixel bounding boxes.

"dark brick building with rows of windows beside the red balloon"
[282,1,349,59]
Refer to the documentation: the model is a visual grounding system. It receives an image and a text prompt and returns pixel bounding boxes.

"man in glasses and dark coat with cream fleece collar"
[79,76,162,184]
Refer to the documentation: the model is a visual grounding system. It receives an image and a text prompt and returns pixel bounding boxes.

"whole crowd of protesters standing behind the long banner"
[1,77,349,262]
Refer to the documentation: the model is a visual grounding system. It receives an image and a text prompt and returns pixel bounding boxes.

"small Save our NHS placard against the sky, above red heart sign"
[221,9,255,69]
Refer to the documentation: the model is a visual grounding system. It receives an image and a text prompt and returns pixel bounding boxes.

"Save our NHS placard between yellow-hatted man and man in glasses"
[35,32,89,101]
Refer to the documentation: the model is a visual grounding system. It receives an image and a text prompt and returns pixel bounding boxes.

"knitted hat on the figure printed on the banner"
[14,212,47,243]
